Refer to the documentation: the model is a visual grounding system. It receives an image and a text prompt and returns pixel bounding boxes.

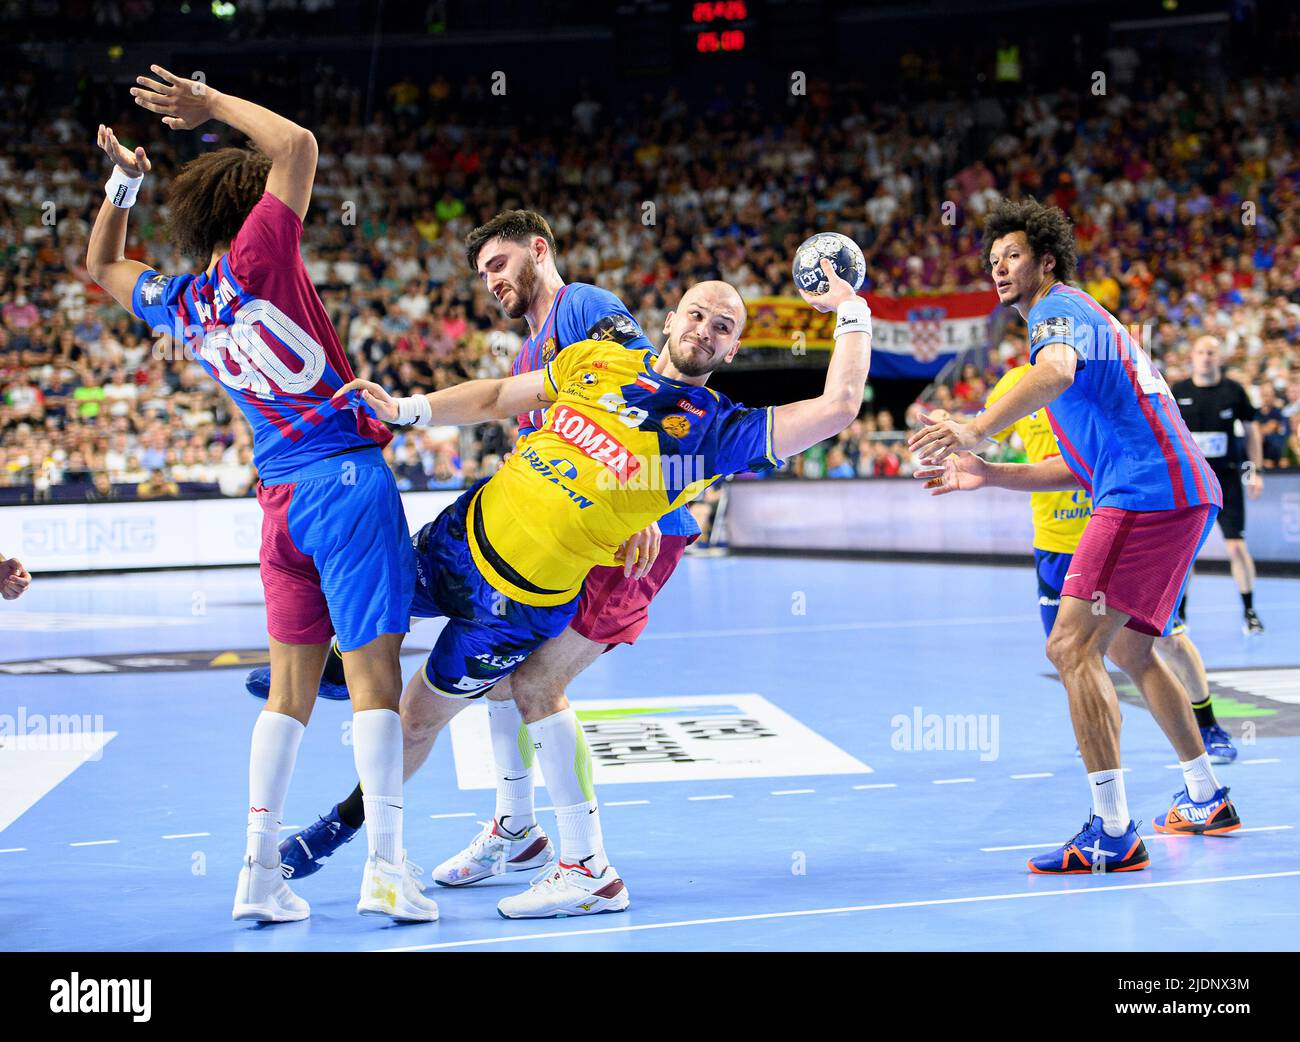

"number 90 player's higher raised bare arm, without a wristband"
[131,65,317,220]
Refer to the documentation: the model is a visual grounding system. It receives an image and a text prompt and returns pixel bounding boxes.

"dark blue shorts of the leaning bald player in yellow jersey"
[411,482,579,698]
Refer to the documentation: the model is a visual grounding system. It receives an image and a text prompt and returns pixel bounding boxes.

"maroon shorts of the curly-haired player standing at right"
[1061,504,1218,637]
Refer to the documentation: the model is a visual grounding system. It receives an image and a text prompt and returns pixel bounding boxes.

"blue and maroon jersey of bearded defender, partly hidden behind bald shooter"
[515,282,699,537]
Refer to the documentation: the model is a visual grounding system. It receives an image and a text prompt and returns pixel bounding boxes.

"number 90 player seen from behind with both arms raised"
[86,65,438,922]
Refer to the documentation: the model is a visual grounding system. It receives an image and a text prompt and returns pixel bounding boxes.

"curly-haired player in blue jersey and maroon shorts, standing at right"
[909,200,1242,873]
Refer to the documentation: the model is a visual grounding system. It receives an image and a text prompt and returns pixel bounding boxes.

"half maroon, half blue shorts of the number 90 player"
[257,447,415,651]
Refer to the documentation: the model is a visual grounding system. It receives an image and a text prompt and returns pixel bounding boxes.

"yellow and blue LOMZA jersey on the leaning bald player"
[467,340,781,607]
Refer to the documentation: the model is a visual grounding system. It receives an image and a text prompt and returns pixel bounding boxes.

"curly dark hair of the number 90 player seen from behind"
[168,148,270,264]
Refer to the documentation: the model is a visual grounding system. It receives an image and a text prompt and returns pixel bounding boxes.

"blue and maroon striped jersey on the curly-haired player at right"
[1027,283,1223,511]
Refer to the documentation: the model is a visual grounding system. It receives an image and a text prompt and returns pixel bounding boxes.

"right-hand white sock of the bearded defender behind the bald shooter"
[528,708,610,876]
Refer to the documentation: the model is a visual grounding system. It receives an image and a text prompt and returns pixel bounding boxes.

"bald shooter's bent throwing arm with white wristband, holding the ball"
[772,259,871,459]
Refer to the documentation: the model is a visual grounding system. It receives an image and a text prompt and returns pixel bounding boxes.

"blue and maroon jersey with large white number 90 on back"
[131,192,393,482]
